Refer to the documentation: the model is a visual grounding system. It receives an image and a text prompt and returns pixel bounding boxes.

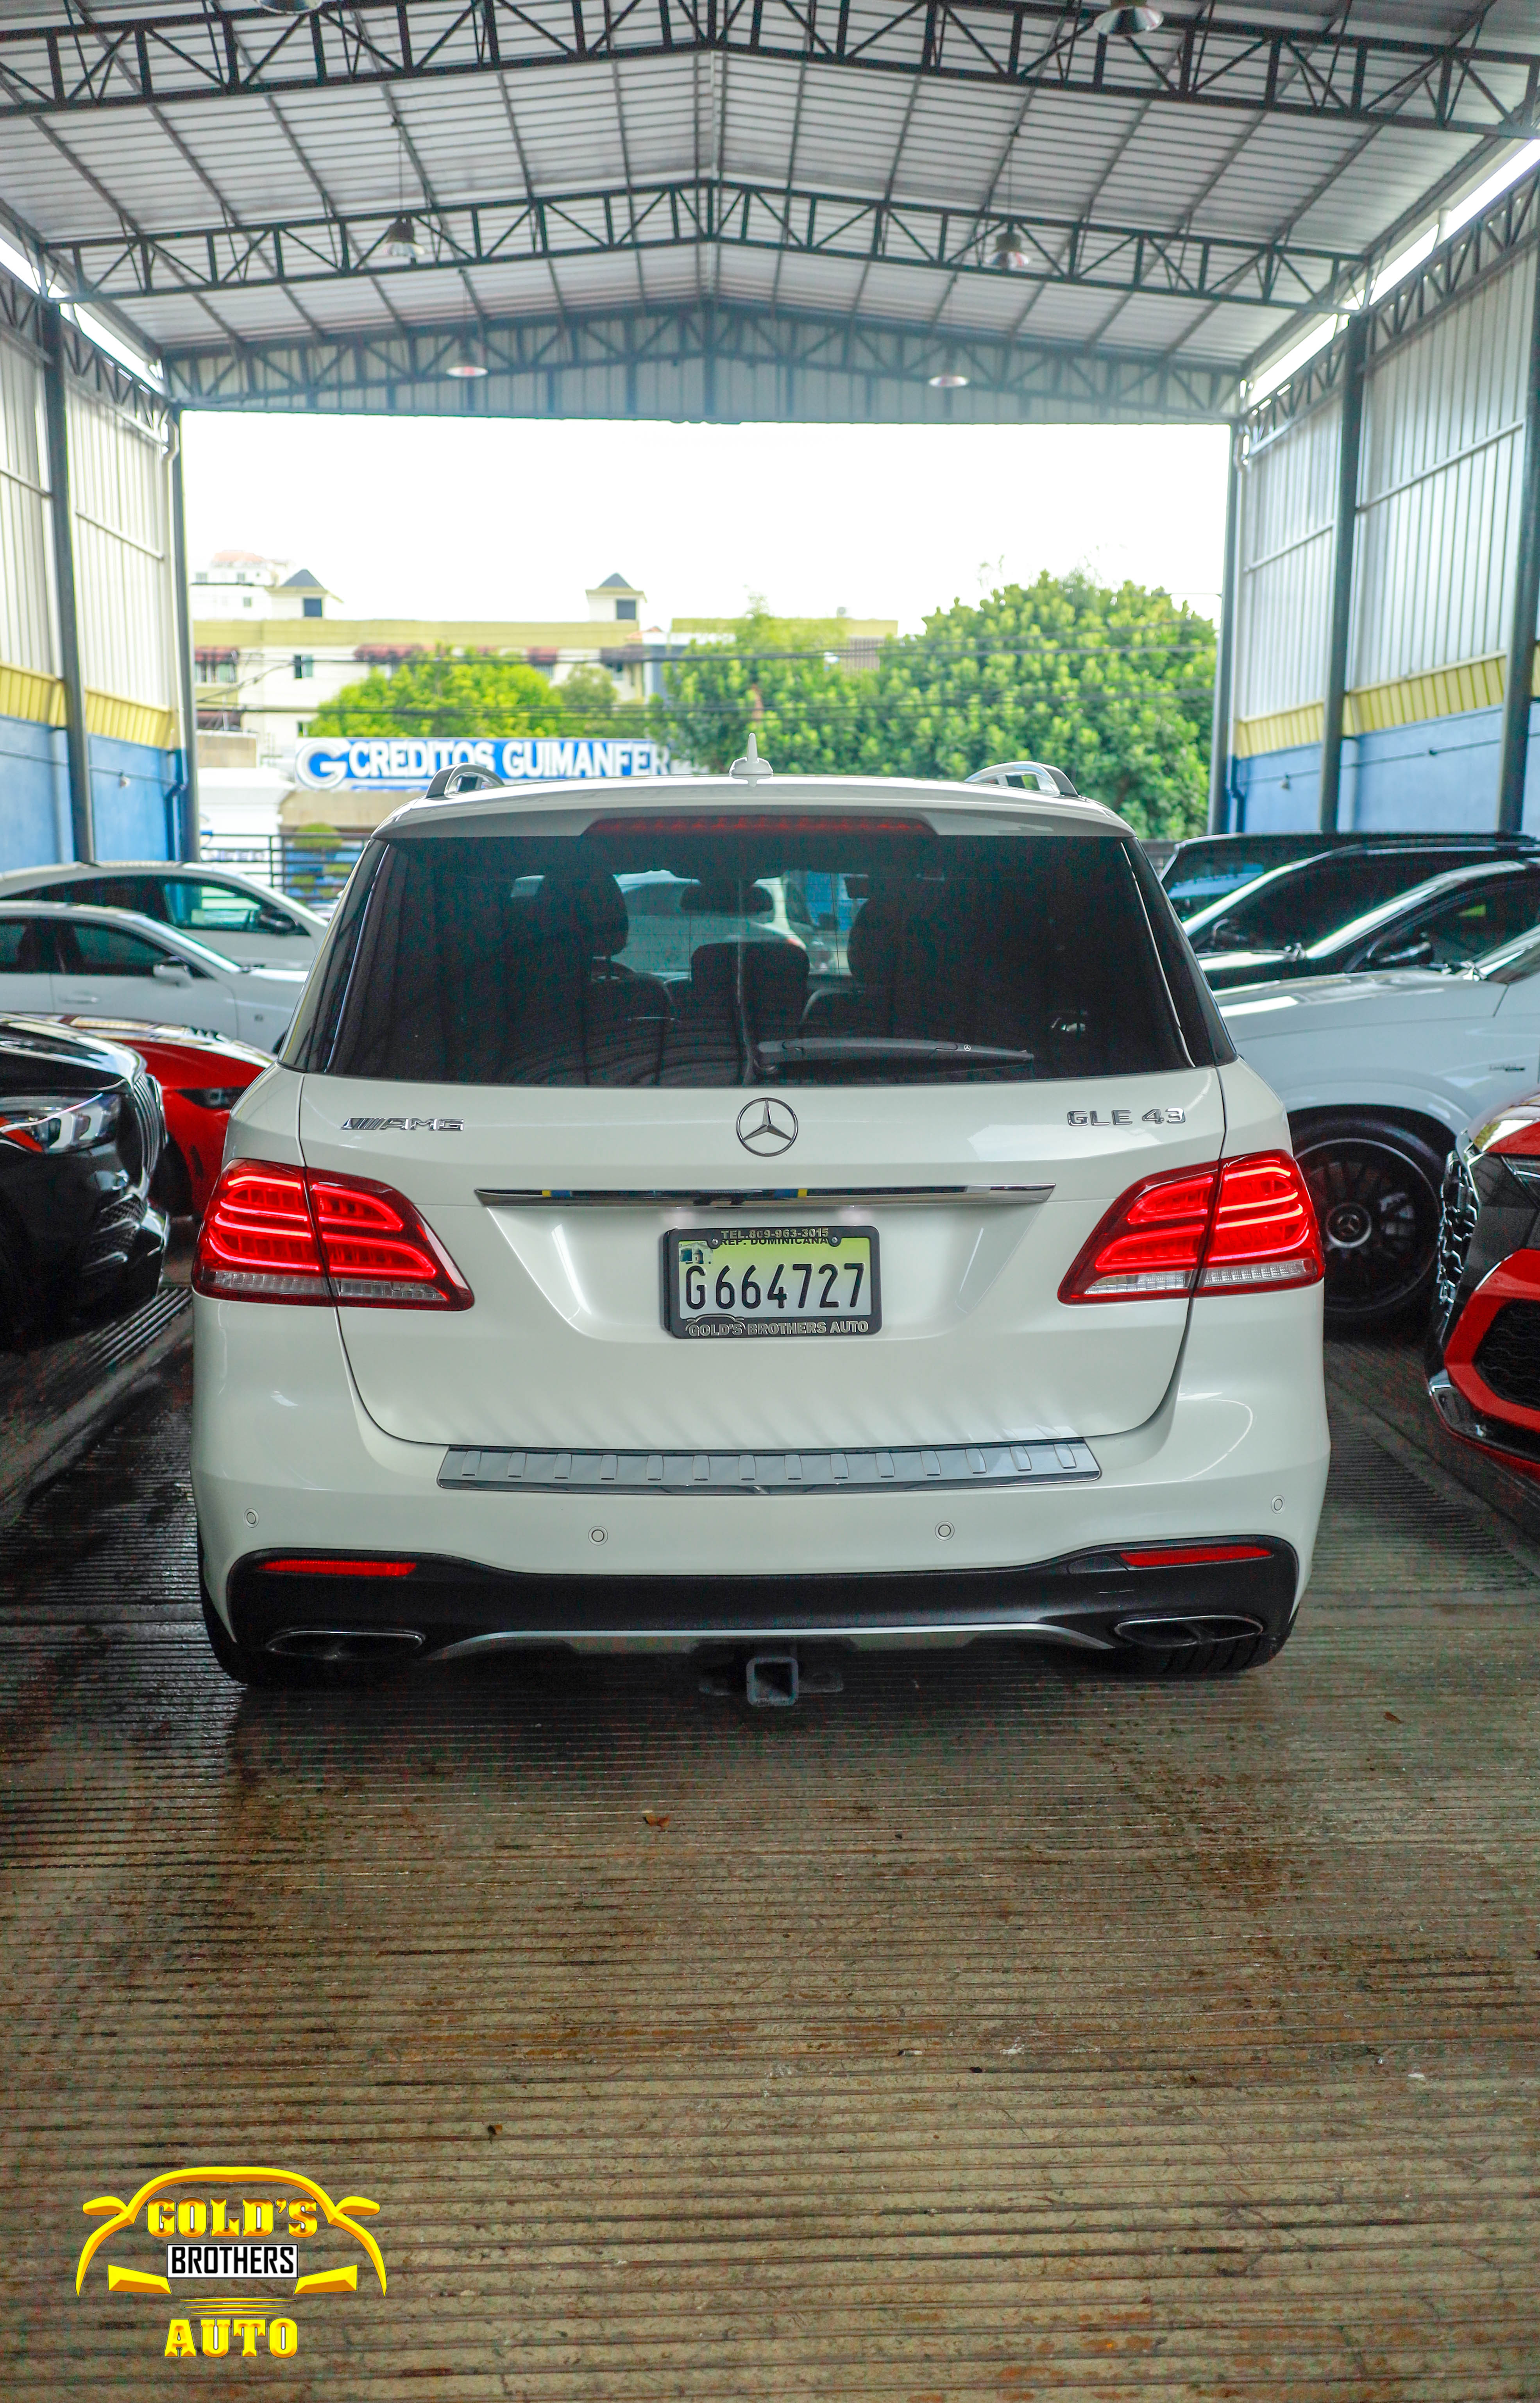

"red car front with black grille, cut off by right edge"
[1427,1093,1540,1475]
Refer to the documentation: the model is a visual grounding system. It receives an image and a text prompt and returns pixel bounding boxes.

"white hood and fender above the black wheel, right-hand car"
[1218,937,1540,1136]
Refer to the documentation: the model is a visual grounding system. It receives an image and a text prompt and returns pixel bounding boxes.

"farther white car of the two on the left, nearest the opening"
[0,860,327,971]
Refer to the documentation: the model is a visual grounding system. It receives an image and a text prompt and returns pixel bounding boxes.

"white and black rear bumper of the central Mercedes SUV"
[192,1288,1329,1644]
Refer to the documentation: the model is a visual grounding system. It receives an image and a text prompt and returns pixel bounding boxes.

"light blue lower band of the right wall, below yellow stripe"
[1230,702,1540,834]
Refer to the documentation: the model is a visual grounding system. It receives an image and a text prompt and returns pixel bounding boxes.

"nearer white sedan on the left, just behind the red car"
[0,901,308,1052]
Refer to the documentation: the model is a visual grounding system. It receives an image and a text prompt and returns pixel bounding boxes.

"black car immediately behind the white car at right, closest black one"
[1199,858,1540,993]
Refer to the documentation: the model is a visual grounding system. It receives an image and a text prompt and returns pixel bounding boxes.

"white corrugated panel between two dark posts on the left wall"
[70,385,178,709]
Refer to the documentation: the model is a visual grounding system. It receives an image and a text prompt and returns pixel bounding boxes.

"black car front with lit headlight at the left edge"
[0,1019,166,1341]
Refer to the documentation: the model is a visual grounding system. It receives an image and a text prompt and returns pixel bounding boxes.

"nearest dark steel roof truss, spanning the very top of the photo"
[0,0,1540,137]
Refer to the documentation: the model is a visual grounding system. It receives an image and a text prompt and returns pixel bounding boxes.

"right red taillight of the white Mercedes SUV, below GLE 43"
[1059,1151,1324,1303]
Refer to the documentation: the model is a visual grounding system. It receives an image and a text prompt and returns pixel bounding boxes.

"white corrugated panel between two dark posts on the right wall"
[1348,257,1535,685]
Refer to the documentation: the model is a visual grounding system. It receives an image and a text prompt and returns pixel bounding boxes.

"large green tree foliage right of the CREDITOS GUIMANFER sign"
[658,574,1213,836]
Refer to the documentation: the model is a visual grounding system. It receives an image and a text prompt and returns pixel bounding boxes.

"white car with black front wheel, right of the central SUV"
[1218,930,1540,1331]
